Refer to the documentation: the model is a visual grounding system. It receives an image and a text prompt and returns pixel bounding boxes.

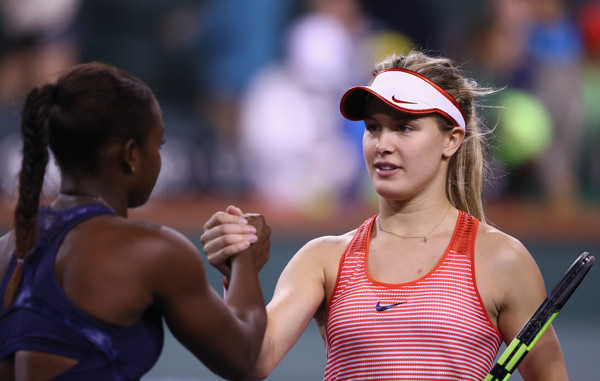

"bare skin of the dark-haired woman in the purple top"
[0,99,270,381]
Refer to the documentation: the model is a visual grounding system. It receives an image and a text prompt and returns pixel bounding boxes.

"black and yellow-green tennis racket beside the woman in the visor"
[484,253,595,381]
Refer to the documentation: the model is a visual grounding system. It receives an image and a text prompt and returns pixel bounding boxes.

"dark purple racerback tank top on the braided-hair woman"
[0,205,163,381]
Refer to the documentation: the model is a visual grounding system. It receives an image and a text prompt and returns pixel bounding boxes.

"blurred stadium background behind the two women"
[0,0,600,381]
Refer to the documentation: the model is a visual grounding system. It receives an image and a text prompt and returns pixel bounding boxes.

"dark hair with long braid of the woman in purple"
[4,62,156,307]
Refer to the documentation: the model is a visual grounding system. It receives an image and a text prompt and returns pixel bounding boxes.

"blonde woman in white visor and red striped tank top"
[202,52,568,381]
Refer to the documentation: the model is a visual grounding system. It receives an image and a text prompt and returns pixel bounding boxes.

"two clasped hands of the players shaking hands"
[200,206,271,279]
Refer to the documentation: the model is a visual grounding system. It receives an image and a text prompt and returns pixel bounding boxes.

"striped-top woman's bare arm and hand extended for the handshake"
[202,207,336,380]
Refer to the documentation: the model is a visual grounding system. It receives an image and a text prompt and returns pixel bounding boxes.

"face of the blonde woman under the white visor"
[363,97,464,201]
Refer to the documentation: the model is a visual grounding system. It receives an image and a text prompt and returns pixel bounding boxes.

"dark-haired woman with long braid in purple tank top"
[0,63,269,381]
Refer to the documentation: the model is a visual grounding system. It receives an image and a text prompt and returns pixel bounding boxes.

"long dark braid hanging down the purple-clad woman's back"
[4,85,52,307]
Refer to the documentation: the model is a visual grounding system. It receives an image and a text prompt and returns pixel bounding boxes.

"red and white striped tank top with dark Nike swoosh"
[325,212,502,381]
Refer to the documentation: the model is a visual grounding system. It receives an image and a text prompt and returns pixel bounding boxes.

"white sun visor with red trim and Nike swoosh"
[340,69,466,129]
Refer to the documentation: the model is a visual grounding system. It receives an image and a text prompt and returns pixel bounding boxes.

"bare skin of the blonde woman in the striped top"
[202,95,568,381]
